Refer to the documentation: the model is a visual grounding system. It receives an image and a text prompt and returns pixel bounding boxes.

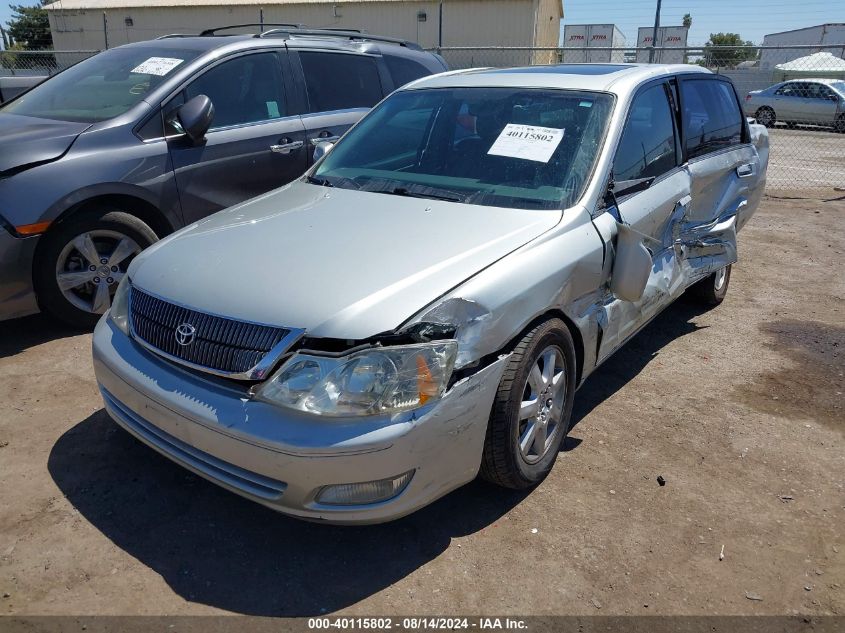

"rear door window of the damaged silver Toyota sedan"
[681,79,742,158]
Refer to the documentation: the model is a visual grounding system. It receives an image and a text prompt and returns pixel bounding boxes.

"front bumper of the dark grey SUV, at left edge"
[0,226,38,321]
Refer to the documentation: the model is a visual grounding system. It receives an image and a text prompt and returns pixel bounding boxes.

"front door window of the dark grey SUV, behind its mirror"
[184,53,286,130]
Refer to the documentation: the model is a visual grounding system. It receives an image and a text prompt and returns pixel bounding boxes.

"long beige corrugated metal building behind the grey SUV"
[46,0,563,55]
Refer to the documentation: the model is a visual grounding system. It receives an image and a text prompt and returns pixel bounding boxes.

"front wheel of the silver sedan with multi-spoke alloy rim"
[480,319,575,490]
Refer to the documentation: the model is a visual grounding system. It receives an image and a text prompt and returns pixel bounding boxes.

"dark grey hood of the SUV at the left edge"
[0,112,91,175]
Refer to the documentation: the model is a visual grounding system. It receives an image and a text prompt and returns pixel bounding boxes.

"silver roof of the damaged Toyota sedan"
[404,64,712,95]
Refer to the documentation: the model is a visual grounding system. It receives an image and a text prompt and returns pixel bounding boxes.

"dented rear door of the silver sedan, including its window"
[677,75,765,283]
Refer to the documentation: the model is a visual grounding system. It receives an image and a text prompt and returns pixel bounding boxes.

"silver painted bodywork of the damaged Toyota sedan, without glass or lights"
[94,66,768,522]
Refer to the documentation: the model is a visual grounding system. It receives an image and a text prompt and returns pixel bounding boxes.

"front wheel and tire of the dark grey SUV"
[33,208,158,329]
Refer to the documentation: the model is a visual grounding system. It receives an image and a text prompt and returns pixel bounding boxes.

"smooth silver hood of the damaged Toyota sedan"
[129,181,561,340]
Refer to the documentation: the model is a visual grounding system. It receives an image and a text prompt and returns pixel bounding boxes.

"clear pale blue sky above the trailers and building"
[0,0,845,46]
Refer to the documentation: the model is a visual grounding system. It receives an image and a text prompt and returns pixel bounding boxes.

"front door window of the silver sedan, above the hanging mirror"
[613,84,677,182]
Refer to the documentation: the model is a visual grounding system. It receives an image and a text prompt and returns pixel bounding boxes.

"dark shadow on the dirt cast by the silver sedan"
[48,296,700,616]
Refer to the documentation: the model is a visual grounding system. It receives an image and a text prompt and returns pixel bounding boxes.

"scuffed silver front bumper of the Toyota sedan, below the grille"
[93,317,507,524]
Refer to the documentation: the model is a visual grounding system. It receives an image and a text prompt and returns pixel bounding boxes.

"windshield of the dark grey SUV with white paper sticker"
[0,46,201,123]
